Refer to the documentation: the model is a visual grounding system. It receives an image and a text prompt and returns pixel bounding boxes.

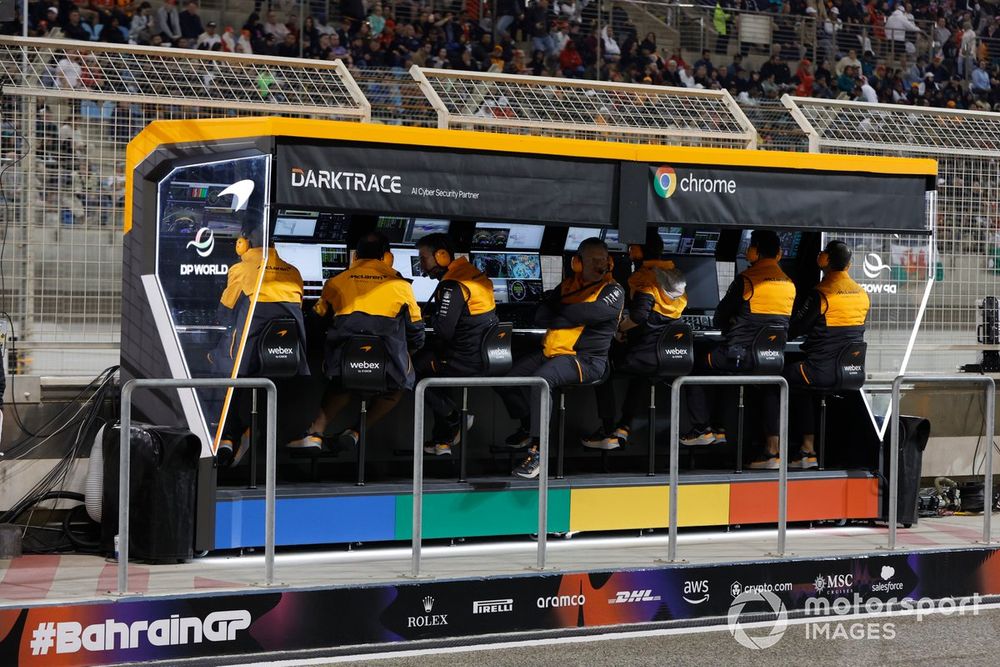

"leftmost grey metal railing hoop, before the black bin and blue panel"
[118,378,278,595]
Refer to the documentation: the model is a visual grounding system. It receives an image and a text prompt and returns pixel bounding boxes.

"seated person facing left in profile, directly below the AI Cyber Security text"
[413,234,498,456]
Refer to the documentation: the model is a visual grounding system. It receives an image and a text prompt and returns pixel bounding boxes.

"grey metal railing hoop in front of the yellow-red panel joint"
[667,375,788,562]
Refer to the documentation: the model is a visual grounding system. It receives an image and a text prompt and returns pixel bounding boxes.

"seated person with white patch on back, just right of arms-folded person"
[583,227,687,449]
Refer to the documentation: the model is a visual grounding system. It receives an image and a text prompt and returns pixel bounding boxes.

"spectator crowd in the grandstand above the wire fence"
[3,0,1000,110]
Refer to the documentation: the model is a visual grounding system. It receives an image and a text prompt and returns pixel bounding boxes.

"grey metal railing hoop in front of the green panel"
[411,377,552,577]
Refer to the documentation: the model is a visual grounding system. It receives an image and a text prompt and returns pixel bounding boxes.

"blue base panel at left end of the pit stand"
[215,496,396,549]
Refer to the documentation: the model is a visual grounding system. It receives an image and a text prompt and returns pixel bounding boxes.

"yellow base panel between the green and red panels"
[569,484,729,530]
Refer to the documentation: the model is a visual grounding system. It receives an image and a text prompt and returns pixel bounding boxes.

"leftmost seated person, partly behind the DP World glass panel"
[218,227,309,467]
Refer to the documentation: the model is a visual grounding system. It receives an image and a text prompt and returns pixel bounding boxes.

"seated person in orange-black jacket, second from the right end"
[681,229,795,469]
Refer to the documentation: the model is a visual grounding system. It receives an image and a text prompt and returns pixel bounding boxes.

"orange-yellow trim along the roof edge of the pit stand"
[125,117,937,233]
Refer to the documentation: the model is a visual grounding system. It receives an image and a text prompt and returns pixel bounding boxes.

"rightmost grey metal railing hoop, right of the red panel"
[886,374,996,550]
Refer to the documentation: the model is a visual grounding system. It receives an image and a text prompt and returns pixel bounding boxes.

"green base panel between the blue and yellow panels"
[396,489,569,540]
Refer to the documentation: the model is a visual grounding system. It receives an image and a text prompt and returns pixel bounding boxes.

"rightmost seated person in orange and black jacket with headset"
[784,241,871,469]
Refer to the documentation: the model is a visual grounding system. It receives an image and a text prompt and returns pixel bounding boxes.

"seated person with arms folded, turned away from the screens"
[496,238,625,479]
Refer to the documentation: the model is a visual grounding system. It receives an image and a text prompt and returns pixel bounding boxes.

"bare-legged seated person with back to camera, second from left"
[288,233,424,450]
